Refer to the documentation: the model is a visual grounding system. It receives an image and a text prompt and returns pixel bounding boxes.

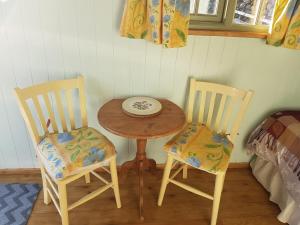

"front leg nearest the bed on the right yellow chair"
[210,173,225,225]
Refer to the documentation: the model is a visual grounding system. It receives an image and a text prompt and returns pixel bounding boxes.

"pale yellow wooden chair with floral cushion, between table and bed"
[158,79,253,225]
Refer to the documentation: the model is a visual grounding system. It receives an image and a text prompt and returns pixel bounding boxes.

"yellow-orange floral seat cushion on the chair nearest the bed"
[164,124,233,172]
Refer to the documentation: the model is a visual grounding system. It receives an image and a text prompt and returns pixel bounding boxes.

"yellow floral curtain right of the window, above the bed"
[267,0,300,49]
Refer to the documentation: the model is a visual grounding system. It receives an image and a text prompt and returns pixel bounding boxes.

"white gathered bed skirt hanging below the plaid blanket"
[250,157,300,225]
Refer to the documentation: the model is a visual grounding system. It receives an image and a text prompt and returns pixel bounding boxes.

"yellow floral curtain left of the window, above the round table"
[120,0,190,48]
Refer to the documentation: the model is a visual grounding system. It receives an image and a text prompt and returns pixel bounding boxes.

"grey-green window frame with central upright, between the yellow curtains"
[189,0,269,34]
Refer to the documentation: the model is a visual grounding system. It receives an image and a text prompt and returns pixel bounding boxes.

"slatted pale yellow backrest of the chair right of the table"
[187,78,253,141]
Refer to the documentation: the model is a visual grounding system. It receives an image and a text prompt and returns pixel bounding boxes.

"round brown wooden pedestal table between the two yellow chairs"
[98,99,186,220]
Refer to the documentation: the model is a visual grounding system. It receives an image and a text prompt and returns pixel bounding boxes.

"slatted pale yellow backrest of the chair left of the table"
[15,76,88,144]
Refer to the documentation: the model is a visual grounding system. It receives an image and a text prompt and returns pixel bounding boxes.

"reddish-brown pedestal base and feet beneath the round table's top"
[121,139,156,220]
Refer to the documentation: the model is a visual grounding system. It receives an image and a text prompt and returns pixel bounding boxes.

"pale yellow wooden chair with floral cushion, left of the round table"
[15,76,121,225]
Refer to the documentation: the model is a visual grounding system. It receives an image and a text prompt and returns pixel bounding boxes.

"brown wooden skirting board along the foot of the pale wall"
[0,162,250,175]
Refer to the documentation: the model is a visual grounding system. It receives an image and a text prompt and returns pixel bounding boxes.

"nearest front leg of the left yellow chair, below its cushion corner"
[58,182,69,225]
